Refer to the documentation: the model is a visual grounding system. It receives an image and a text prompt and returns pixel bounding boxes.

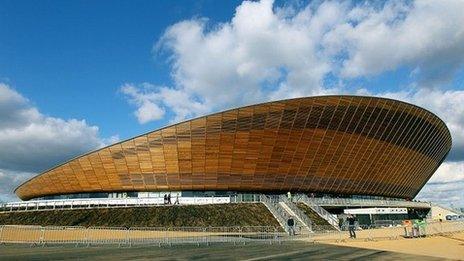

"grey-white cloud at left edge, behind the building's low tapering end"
[0,83,114,198]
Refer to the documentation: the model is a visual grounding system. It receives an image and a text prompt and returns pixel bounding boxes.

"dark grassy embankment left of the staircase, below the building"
[0,203,279,227]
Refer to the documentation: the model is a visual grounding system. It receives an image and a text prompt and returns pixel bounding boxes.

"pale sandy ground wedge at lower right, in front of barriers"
[322,232,464,260]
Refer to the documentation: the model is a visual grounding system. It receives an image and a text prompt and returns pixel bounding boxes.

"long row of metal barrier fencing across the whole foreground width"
[0,221,464,246]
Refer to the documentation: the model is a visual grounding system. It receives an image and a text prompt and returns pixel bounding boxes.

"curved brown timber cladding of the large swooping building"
[15,96,451,199]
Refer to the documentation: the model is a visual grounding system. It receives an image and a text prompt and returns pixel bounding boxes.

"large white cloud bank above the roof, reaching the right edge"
[117,0,464,205]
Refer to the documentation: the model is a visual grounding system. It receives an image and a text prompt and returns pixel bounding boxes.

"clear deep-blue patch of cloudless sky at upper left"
[0,1,243,138]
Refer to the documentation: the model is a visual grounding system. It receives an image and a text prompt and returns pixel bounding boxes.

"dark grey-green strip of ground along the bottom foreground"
[0,241,440,261]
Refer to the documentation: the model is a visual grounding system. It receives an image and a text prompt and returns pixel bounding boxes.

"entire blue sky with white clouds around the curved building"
[0,0,464,207]
